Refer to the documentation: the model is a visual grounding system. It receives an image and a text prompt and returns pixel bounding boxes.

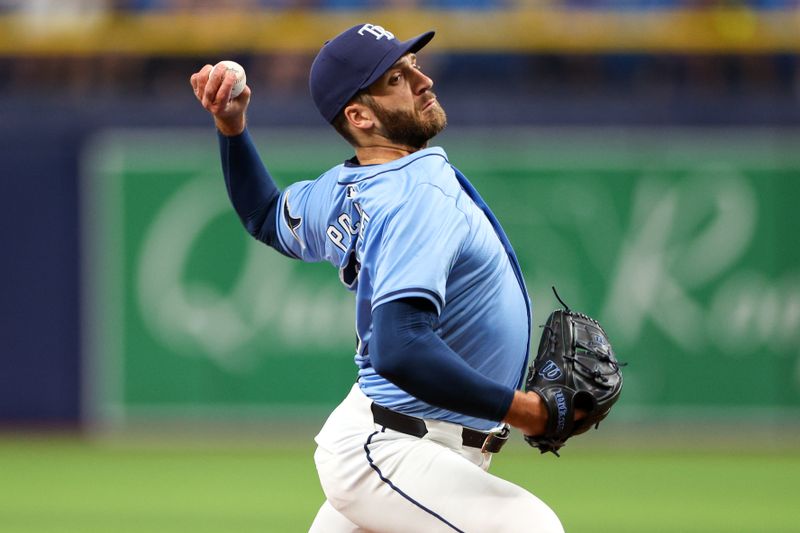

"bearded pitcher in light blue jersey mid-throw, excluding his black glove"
[191,24,563,533]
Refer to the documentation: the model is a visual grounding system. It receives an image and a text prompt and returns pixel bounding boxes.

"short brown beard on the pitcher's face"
[370,94,447,149]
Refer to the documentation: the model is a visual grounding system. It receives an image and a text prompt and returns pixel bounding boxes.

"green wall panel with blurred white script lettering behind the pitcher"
[82,128,800,421]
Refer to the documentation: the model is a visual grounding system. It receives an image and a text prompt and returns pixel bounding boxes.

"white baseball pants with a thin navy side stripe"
[309,384,564,533]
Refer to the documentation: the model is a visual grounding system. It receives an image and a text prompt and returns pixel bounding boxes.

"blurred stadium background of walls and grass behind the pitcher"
[0,0,800,533]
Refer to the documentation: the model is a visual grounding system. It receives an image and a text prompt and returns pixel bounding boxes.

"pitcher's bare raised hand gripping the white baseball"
[189,65,251,137]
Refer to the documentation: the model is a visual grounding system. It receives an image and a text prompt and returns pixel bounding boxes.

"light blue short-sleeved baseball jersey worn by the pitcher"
[276,147,530,430]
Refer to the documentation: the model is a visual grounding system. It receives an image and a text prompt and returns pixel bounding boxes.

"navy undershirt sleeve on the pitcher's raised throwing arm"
[217,129,291,257]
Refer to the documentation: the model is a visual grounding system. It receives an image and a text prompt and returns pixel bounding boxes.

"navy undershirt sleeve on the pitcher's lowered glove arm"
[369,298,514,422]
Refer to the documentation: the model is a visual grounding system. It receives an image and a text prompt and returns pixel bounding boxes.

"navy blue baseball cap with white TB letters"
[308,24,434,122]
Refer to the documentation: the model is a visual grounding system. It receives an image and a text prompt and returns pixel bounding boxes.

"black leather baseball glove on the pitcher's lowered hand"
[525,288,624,455]
